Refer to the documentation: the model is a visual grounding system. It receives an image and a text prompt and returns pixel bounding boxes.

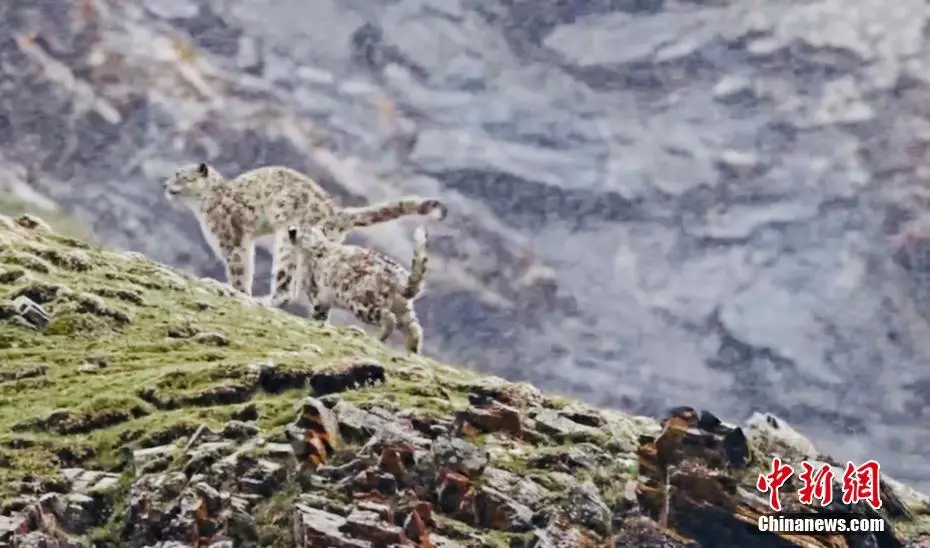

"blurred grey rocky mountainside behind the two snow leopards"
[0,0,930,485]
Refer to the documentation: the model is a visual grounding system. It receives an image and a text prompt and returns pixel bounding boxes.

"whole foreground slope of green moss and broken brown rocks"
[0,216,930,548]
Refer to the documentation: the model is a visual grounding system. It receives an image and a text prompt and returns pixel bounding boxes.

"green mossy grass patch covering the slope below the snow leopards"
[0,225,486,498]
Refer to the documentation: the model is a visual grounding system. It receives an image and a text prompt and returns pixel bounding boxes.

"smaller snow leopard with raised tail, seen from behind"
[288,223,428,354]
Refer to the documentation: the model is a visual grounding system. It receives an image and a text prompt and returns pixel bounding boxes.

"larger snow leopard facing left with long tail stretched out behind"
[164,163,446,306]
